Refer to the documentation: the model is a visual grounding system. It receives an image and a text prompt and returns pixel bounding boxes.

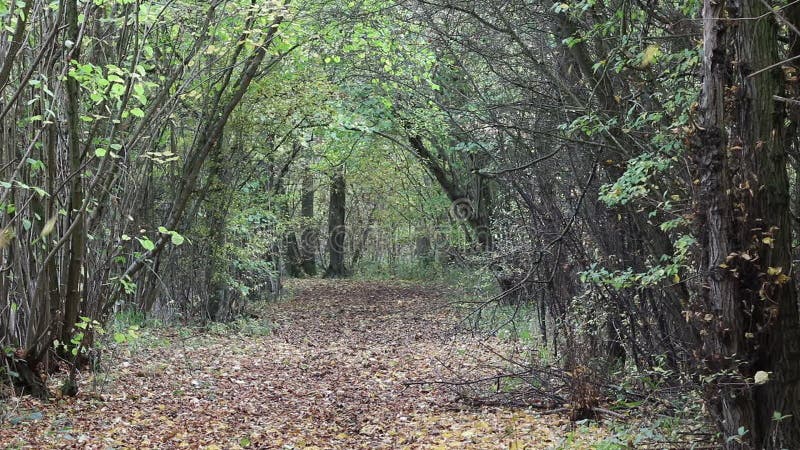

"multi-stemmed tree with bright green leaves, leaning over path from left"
[0,0,291,396]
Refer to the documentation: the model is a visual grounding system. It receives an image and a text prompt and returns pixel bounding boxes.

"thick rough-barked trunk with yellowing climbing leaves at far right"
[693,0,800,449]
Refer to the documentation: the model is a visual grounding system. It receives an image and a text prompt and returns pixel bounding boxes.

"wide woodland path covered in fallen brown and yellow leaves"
[0,280,606,450]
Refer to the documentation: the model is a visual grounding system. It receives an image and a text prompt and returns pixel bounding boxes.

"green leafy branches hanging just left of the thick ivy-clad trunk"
[554,1,700,298]
